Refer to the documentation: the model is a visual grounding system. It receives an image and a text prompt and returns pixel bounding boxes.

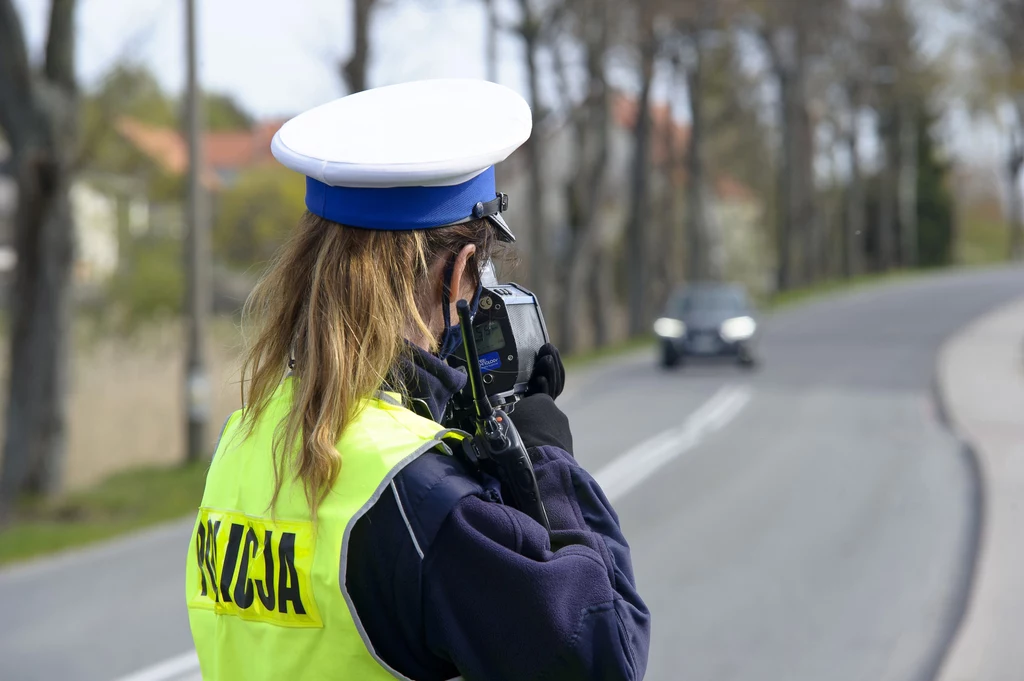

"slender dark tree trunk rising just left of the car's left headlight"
[626,25,657,336]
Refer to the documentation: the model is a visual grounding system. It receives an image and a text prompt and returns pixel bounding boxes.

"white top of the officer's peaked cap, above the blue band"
[271,79,532,187]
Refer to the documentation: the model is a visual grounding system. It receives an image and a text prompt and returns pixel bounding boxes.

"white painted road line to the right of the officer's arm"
[594,385,753,501]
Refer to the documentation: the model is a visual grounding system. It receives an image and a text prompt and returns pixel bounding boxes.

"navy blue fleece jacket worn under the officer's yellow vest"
[346,352,650,681]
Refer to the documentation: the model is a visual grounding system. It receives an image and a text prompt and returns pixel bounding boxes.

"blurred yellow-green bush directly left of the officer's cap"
[213,165,305,268]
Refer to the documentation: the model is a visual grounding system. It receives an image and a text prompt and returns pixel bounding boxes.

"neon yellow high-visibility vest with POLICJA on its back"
[185,379,461,681]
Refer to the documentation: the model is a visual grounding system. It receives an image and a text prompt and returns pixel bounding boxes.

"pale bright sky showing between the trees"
[6,0,1000,178]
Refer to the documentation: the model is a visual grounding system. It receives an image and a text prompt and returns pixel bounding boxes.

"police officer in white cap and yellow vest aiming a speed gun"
[186,80,650,681]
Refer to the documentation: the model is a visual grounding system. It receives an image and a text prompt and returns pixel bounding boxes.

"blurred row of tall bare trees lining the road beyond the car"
[341,0,958,342]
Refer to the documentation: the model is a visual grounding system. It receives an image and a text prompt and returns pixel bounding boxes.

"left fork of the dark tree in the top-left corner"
[0,0,34,142]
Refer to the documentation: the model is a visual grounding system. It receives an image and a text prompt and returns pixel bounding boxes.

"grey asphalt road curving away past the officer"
[0,270,1024,681]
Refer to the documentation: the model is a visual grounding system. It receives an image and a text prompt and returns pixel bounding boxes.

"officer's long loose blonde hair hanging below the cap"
[242,212,494,517]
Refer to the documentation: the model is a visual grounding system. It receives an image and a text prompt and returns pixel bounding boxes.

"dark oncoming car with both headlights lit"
[654,283,758,368]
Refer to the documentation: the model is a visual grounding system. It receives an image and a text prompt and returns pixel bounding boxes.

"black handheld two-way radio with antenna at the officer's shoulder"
[456,298,551,533]
